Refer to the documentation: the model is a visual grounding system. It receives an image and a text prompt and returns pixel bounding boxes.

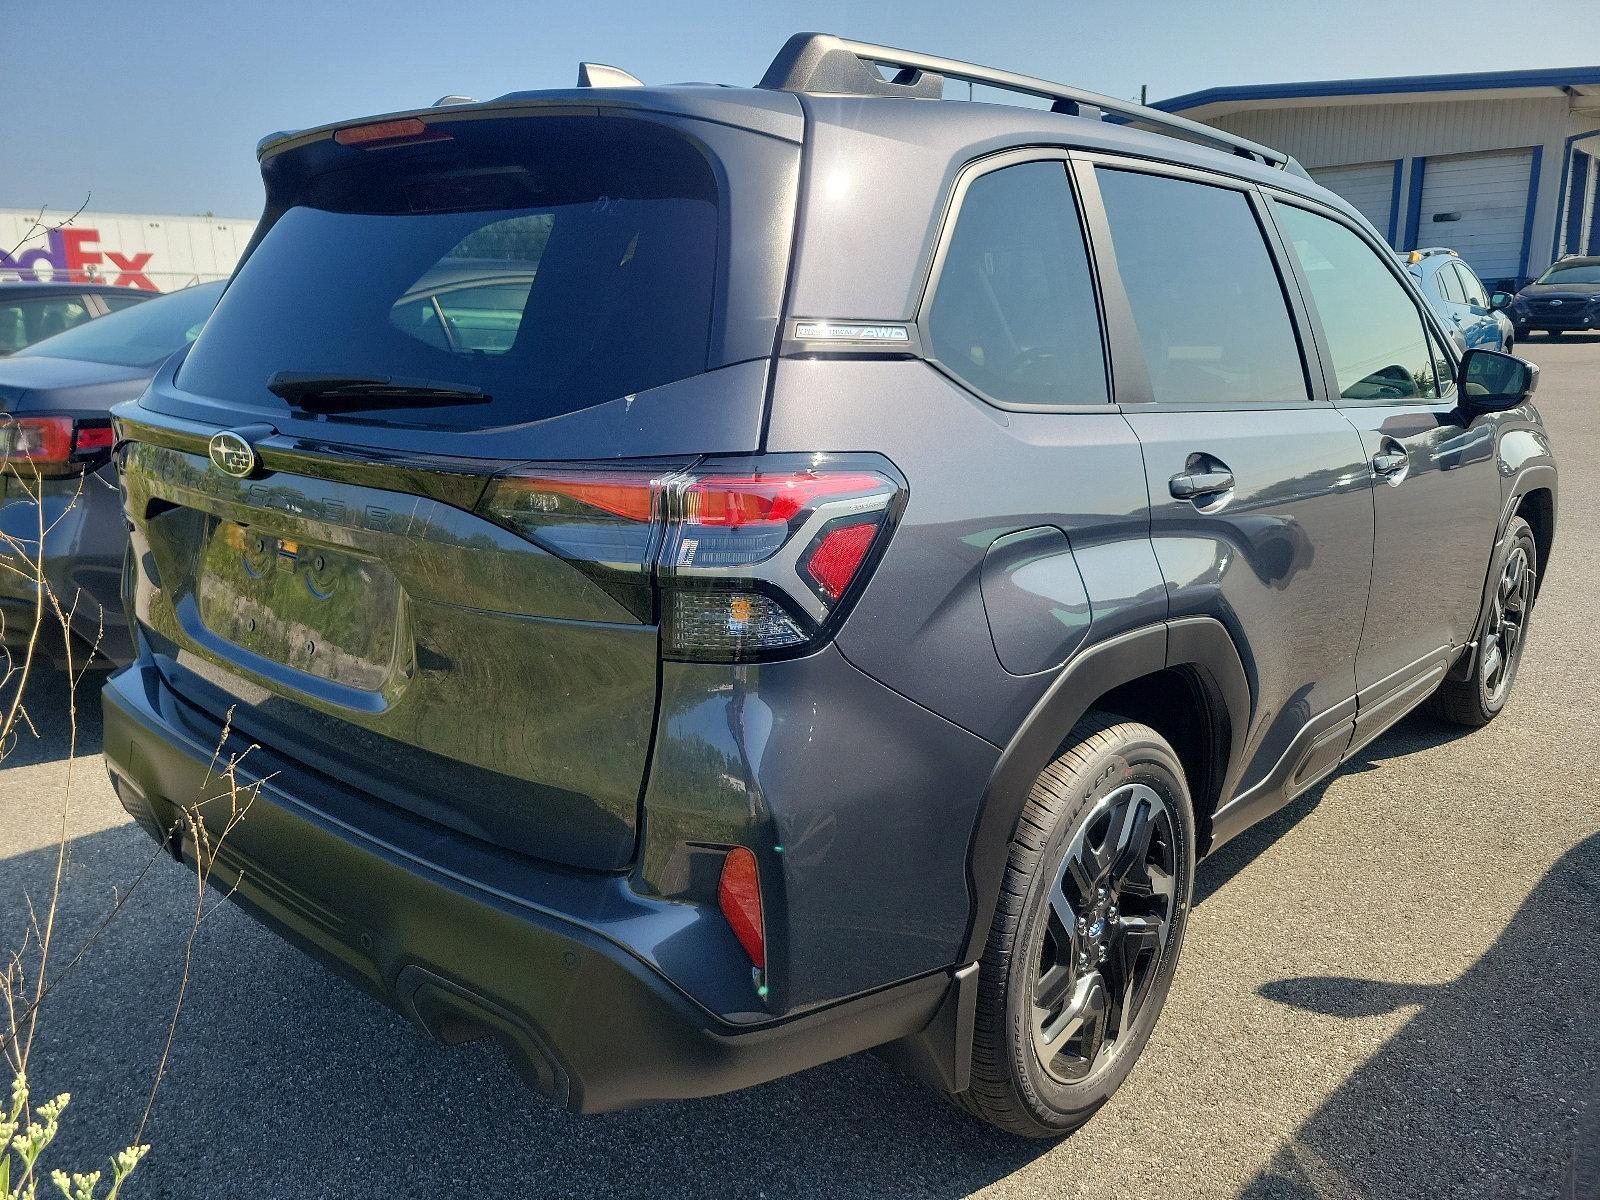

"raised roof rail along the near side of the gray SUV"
[757,34,1304,174]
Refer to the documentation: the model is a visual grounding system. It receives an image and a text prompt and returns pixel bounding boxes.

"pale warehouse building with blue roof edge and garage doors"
[1155,67,1600,285]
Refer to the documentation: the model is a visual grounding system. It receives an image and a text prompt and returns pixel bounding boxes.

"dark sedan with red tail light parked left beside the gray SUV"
[0,283,222,662]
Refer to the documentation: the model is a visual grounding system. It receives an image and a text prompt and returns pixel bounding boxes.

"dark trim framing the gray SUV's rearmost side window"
[912,146,1120,413]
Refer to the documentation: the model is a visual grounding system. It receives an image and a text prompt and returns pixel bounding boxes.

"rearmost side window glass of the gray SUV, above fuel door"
[926,160,1107,406]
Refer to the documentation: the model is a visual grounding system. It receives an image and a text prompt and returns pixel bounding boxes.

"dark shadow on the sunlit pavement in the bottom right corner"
[1243,834,1600,1200]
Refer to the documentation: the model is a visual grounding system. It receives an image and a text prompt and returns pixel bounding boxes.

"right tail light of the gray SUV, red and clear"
[482,454,906,662]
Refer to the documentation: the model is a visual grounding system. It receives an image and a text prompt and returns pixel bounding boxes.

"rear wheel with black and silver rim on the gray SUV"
[957,715,1195,1138]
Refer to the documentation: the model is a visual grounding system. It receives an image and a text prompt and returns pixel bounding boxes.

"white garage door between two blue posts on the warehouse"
[1416,150,1533,282]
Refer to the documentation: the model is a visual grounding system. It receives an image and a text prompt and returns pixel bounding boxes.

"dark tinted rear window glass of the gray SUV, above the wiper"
[178,117,718,427]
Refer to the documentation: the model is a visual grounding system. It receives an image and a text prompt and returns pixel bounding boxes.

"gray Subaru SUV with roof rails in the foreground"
[104,35,1555,1136]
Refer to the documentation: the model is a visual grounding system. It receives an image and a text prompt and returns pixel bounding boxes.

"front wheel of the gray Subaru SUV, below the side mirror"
[1427,517,1539,728]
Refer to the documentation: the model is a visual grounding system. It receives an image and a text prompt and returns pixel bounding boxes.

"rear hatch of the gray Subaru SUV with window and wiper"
[117,98,800,869]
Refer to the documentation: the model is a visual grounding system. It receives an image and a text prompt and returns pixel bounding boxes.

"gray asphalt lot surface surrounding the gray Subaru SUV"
[0,338,1600,1200]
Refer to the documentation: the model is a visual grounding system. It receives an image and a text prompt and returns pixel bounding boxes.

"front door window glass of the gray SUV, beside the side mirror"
[1272,200,1440,400]
